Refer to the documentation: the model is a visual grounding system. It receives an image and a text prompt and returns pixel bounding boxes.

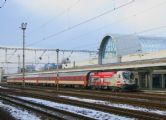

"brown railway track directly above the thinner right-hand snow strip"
[1,87,166,110]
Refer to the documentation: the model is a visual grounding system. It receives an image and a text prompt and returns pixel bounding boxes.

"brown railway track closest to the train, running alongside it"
[2,86,166,102]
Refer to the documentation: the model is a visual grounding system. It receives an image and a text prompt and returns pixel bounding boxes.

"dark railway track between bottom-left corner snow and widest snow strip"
[0,93,94,120]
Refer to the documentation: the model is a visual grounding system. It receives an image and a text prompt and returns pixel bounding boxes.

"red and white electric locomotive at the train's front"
[89,71,137,91]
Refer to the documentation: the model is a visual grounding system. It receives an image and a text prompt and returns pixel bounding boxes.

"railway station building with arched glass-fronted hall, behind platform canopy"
[98,34,166,90]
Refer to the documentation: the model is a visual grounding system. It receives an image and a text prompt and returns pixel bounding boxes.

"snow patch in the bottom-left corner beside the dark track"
[0,102,40,120]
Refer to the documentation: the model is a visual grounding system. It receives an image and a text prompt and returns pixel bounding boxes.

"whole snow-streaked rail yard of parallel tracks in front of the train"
[0,84,166,120]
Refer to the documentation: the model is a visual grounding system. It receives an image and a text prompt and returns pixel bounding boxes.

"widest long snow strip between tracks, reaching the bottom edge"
[17,96,134,120]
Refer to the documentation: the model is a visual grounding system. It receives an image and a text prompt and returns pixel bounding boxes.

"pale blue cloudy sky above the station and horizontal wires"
[0,0,166,50]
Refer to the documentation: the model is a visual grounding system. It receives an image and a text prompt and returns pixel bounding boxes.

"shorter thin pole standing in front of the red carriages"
[56,49,60,91]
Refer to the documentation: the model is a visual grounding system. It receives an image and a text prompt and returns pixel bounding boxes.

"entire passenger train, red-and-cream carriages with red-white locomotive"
[7,71,137,91]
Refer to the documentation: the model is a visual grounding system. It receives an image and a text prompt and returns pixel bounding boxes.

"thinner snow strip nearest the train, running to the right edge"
[59,95,166,115]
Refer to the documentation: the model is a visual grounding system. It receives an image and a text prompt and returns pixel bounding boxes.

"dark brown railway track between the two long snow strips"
[0,87,166,120]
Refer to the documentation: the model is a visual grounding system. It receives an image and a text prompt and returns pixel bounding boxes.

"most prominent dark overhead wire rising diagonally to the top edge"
[28,0,135,46]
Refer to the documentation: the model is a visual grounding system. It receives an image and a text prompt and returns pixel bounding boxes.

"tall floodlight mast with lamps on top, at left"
[21,23,27,87]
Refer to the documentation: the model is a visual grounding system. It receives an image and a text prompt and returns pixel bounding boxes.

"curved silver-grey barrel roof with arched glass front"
[99,34,166,64]
